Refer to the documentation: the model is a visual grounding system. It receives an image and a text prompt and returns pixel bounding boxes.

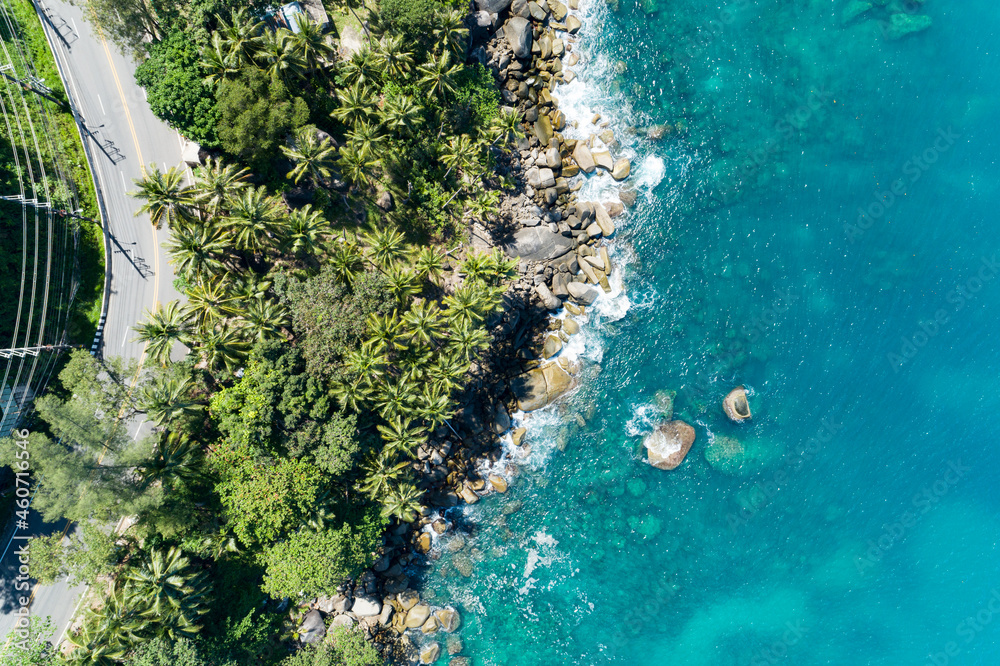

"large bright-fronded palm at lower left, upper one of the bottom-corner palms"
[122,547,210,639]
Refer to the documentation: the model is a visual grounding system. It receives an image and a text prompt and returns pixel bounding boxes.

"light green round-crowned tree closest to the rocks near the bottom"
[263,508,386,599]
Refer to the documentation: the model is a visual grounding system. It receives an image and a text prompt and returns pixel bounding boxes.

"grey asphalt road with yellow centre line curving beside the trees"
[0,0,181,639]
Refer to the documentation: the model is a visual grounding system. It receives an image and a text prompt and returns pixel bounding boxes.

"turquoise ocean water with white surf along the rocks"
[414,0,1000,666]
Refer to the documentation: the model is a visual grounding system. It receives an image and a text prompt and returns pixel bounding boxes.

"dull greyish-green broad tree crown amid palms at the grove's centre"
[275,266,394,377]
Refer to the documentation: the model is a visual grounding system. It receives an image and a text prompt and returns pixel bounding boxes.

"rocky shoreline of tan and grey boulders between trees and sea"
[298,0,635,666]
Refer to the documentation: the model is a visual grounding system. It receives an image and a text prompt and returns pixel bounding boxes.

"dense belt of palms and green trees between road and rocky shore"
[3,0,519,666]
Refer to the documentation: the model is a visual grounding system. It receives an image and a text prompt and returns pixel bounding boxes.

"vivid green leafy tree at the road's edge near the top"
[135,31,219,148]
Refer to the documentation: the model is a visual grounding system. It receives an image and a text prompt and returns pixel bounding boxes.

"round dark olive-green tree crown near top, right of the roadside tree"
[216,67,309,164]
